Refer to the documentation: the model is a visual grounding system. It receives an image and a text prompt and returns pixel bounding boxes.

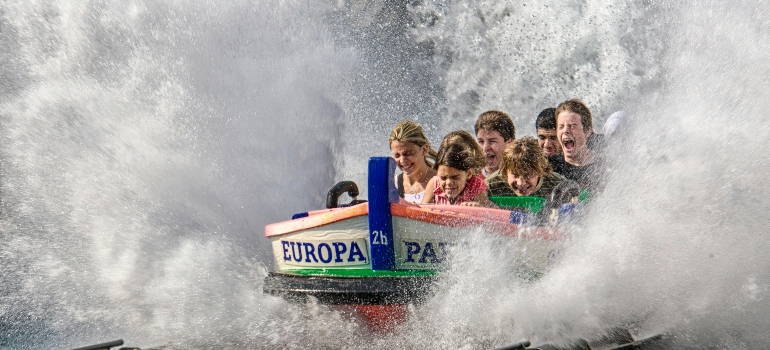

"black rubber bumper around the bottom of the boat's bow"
[263,272,435,305]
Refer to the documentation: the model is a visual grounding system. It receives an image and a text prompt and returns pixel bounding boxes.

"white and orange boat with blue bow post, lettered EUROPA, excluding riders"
[264,157,574,305]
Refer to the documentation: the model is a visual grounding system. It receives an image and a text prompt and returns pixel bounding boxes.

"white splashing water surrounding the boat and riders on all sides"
[0,1,770,349]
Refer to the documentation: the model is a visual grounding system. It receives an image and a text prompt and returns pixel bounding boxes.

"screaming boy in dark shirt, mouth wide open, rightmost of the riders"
[548,99,603,191]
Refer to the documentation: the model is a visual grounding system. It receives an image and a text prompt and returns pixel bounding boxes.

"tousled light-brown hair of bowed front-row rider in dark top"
[500,136,553,177]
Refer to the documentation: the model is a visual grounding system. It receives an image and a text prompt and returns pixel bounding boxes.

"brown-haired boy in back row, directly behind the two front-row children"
[473,111,516,177]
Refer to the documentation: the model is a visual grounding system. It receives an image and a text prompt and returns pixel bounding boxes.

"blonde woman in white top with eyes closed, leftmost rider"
[390,120,436,203]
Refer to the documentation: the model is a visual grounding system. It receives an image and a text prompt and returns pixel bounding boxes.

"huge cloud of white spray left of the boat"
[0,1,355,348]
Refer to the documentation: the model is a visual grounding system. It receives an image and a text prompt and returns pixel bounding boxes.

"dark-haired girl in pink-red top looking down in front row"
[422,139,495,207]
